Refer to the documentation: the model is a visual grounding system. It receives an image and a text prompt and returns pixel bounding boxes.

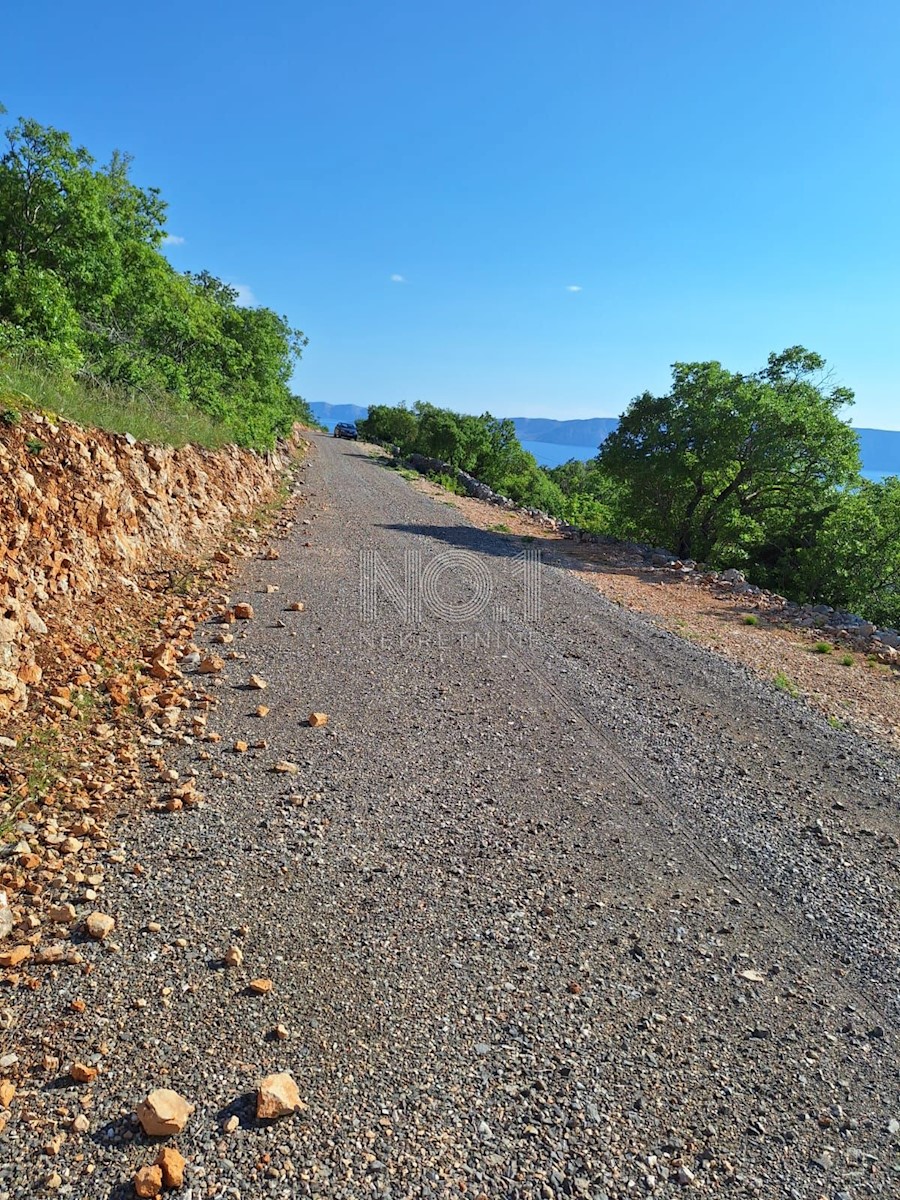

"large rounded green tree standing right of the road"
[599,346,859,562]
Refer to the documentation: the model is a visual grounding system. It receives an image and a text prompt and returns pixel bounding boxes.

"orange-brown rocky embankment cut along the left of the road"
[0,414,301,719]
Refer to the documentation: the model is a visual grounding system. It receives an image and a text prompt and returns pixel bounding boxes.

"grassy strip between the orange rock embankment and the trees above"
[0,364,234,454]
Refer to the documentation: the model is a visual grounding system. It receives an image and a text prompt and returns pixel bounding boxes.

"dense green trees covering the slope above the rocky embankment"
[0,109,311,449]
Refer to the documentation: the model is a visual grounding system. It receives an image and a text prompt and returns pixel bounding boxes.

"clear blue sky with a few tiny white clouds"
[0,0,900,428]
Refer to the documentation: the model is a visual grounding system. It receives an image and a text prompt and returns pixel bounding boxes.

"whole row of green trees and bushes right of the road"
[360,347,900,625]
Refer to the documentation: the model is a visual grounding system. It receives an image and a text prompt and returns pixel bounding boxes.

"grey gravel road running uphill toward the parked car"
[8,437,900,1200]
